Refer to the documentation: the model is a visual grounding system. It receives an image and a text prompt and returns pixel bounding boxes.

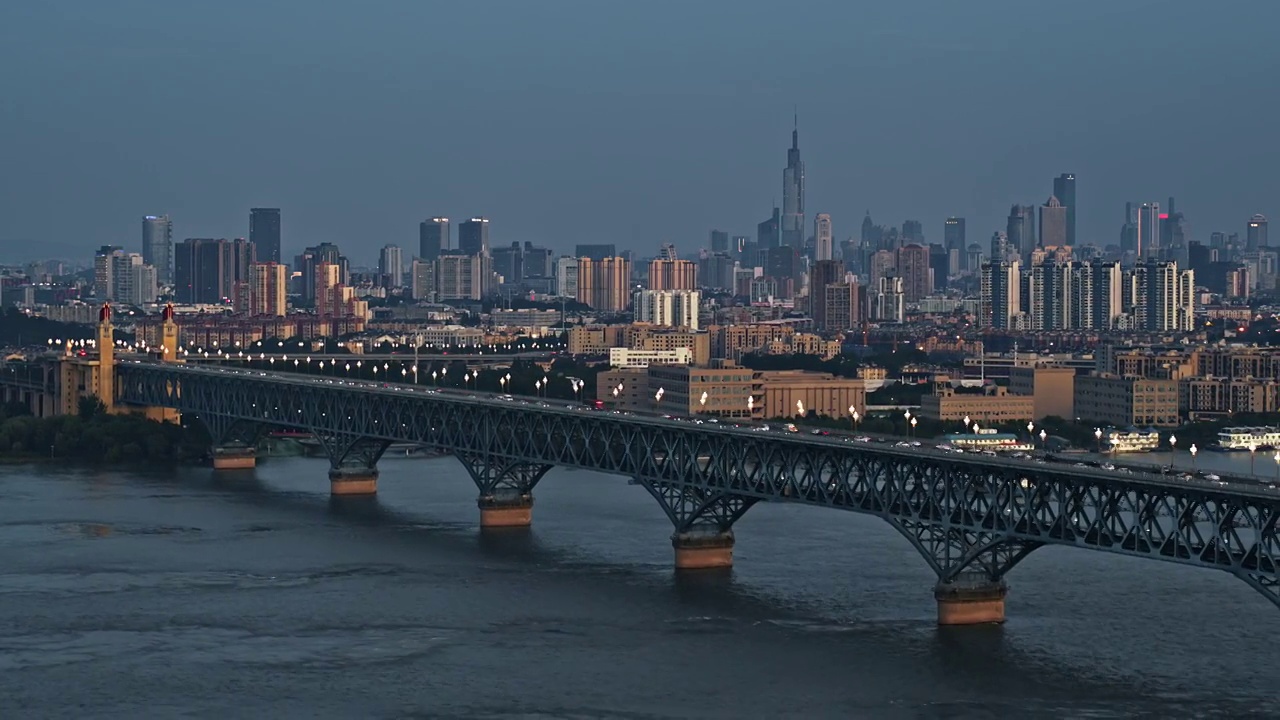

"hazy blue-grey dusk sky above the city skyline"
[0,0,1280,264]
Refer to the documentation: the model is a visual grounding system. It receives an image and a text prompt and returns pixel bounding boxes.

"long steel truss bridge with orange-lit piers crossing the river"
[107,360,1280,624]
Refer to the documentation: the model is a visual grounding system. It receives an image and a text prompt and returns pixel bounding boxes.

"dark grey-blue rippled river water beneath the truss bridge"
[0,457,1280,719]
